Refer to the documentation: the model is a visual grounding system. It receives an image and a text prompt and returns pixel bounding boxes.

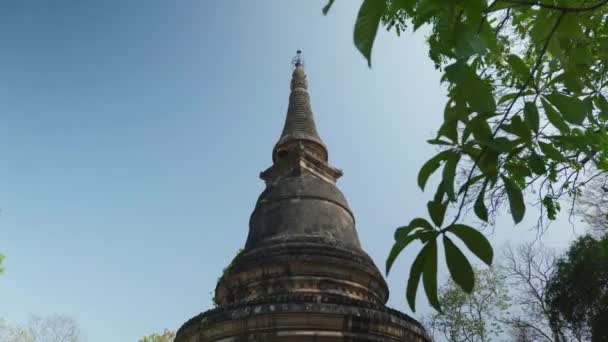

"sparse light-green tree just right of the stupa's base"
[424,268,509,342]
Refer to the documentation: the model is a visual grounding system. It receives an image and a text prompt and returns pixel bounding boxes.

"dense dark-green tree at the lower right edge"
[546,235,608,342]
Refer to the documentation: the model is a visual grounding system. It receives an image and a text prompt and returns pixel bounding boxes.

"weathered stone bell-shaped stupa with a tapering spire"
[175,51,431,342]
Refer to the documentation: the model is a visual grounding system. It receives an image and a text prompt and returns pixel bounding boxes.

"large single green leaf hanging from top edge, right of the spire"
[354,0,386,67]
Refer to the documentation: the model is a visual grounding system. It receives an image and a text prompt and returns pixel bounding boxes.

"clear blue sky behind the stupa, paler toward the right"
[0,0,573,342]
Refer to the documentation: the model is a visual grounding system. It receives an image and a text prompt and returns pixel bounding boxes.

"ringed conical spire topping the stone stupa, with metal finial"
[272,50,327,162]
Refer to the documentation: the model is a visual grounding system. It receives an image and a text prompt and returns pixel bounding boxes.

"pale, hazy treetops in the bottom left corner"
[0,315,85,342]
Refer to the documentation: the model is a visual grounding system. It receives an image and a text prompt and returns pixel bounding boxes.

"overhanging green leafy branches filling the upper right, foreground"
[324,0,608,310]
